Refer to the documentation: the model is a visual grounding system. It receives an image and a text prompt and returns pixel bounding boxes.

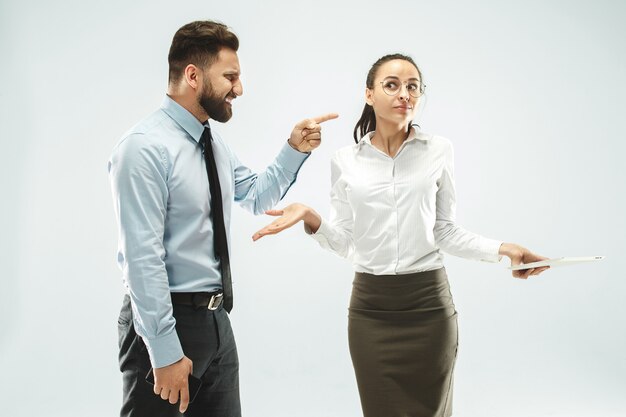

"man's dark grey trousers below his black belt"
[118,295,241,417]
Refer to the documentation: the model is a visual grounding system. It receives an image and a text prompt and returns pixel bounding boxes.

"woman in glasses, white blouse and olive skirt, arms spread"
[253,54,546,417]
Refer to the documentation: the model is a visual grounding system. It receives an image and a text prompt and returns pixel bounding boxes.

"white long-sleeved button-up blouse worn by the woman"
[311,128,502,275]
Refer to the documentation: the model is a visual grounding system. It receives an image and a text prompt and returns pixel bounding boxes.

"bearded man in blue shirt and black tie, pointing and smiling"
[108,21,337,417]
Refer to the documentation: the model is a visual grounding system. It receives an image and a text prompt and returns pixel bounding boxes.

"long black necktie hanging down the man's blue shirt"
[200,125,233,313]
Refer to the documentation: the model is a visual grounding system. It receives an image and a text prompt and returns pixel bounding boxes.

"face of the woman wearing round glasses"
[365,59,422,129]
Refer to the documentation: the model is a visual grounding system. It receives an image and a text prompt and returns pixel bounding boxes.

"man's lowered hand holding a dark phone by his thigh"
[154,356,193,413]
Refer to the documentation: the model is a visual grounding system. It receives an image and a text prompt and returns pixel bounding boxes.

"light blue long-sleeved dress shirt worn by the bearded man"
[108,96,309,368]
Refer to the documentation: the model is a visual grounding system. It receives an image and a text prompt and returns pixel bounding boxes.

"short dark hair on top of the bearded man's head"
[167,20,239,83]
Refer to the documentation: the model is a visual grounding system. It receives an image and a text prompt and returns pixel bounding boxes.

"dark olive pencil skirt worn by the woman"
[348,268,458,417]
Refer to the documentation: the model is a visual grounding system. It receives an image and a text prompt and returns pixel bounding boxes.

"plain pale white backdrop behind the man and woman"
[0,0,626,417]
